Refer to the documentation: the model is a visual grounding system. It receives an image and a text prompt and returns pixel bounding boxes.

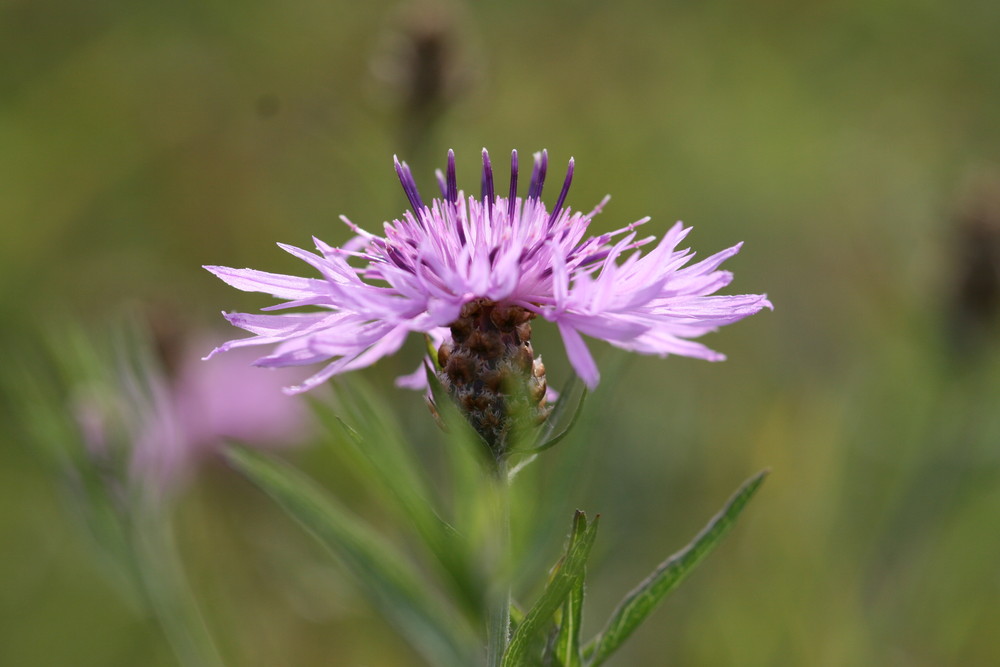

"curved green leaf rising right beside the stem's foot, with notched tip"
[501,511,600,667]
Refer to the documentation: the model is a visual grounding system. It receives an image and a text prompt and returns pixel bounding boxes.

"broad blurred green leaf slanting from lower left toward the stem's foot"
[226,447,478,665]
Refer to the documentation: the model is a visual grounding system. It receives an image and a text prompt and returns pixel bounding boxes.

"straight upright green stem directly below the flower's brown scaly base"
[486,460,510,667]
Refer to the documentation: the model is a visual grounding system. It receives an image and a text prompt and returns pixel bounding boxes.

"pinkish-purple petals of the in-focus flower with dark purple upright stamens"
[205,149,771,393]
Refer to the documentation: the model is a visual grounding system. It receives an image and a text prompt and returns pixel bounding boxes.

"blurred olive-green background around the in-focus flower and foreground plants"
[0,0,1000,666]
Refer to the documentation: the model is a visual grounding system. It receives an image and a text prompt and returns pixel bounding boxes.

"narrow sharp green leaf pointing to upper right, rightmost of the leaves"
[584,470,769,667]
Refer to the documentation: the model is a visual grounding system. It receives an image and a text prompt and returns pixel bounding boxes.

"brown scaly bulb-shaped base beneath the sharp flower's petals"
[438,299,552,459]
